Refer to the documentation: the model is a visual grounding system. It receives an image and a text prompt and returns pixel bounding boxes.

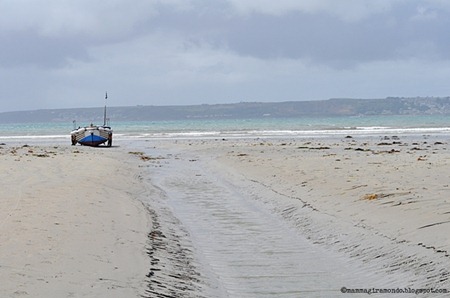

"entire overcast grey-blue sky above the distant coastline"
[0,0,450,112]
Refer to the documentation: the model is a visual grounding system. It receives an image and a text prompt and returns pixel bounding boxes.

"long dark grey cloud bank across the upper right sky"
[135,1,450,66]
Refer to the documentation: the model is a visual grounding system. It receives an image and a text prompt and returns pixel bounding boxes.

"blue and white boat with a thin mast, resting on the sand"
[70,93,113,147]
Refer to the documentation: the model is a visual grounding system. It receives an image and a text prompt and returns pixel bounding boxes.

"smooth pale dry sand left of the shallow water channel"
[0,145,151,297]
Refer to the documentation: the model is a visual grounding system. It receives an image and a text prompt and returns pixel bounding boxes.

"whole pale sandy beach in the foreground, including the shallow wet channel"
[0,135,450,297]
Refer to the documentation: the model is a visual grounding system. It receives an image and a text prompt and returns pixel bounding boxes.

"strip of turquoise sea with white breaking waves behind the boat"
[0,115,450,143]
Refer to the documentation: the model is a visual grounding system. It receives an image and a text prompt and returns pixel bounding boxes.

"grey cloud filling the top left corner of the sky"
[0,0,158,68]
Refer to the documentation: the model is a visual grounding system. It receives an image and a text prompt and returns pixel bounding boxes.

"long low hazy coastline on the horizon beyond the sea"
[0,97,450,123]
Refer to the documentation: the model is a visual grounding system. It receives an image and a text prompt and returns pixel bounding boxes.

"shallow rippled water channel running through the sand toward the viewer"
[151,151,370,297]
